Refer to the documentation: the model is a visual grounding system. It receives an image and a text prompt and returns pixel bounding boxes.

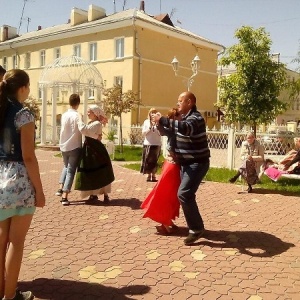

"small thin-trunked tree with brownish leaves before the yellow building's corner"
[103,85,140,153]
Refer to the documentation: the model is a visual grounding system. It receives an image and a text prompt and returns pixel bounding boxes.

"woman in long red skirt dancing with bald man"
[141,108,180,234]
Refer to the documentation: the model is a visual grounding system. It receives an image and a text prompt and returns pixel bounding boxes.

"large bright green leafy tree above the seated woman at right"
[218,26,288,135]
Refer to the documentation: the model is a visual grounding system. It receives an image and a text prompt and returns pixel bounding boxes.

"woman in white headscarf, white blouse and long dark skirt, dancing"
[75,105,115,203]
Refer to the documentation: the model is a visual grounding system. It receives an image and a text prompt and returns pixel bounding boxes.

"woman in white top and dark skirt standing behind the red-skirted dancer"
[141,108,161,182]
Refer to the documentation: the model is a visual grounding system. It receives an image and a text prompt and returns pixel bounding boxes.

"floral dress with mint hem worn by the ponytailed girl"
[0,108,35,221]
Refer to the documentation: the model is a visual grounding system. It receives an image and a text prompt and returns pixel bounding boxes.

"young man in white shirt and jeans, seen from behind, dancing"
[55,94,82,206]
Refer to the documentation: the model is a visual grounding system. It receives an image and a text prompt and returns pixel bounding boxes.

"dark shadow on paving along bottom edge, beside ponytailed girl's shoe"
[19,278,150,300]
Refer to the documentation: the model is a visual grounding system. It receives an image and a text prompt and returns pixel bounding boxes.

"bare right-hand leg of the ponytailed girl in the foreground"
[4,215,33,298]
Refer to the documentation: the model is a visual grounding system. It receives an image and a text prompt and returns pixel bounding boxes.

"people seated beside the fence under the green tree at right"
[229,132,300,193]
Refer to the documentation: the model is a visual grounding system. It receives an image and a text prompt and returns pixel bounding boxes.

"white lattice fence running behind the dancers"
[36,125,300,169]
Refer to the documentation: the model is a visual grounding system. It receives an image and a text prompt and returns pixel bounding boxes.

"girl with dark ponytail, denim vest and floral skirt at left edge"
[0,69,45,300]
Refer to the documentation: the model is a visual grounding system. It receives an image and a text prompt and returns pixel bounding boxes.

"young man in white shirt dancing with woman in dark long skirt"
[56,94,114,206]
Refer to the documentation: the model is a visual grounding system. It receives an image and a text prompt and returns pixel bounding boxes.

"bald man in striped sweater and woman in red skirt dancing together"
[141,92,210,245]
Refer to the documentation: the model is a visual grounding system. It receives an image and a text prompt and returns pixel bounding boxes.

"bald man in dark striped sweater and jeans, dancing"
[154,92,210,245]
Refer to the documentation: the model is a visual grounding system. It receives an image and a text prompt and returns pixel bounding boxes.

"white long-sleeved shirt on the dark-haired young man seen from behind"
[59,108,82,152]
